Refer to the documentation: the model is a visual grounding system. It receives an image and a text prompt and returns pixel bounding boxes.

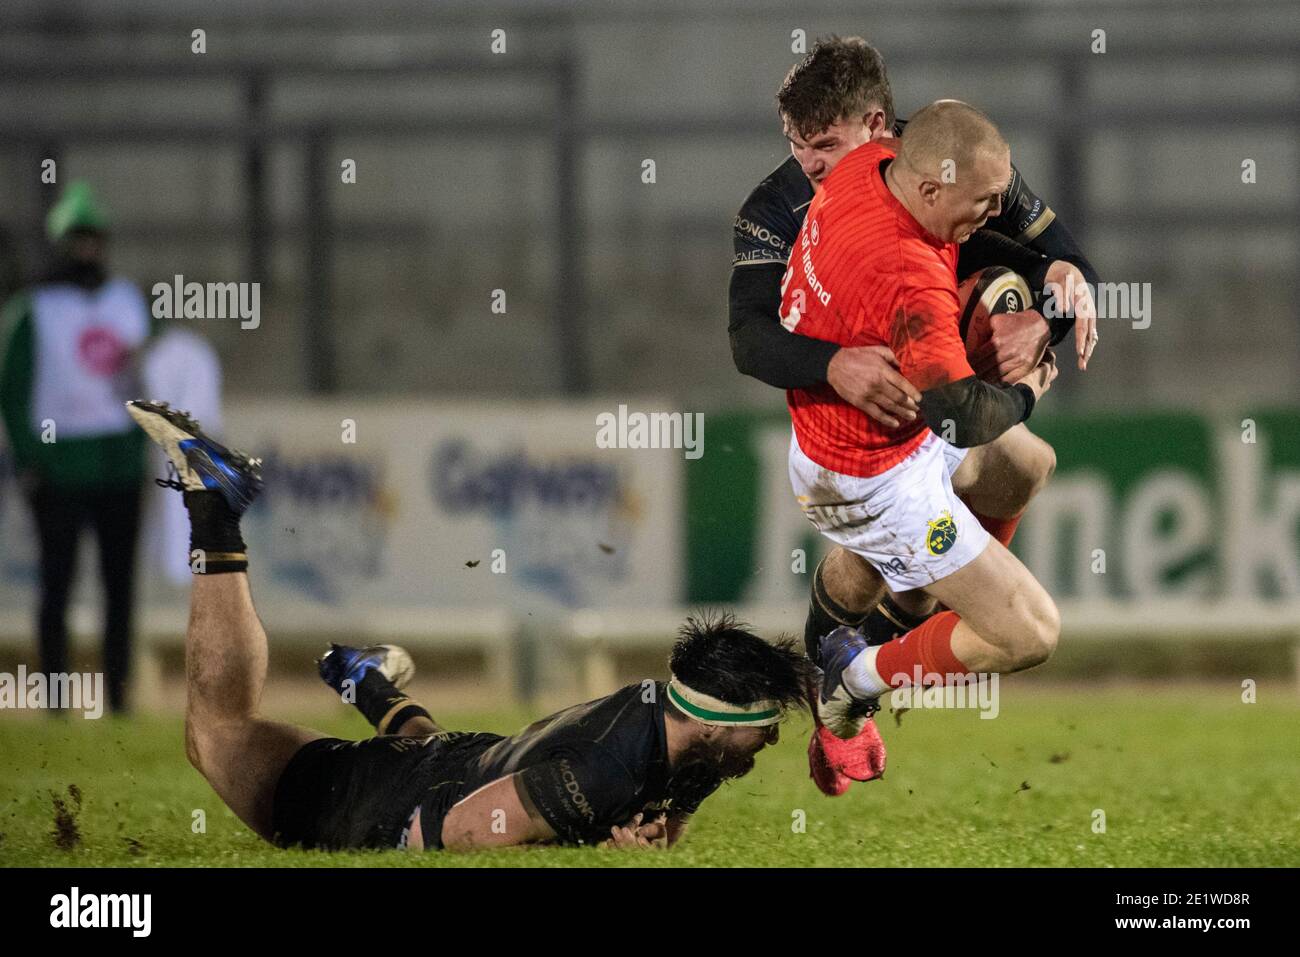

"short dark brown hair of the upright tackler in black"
[776,36,894,139]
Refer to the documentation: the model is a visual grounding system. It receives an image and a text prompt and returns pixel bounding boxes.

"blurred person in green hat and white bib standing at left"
[0,182,150,714]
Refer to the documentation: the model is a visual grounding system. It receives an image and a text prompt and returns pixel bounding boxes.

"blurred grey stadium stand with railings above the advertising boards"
[0,0,1300,411]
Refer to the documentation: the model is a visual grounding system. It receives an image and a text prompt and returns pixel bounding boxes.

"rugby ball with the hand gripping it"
[957,265,1050,384]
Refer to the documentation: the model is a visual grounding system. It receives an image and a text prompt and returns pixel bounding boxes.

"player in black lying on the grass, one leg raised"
[127,402,811,850]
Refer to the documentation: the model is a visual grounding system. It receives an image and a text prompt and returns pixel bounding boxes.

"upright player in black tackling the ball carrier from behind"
[729,36,1097,794]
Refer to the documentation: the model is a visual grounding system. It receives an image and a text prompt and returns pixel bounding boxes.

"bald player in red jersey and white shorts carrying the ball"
[780,100,1060,769]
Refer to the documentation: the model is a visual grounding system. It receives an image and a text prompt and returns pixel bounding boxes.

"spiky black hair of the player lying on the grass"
[668,611,813,707]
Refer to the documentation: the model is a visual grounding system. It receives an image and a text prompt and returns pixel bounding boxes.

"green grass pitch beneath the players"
[0,681,1300,867]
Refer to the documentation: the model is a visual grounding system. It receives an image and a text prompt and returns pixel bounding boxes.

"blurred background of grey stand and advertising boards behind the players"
[0,0,1300,702]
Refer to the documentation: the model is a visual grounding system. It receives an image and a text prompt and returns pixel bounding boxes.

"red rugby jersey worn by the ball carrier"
[781,143,975,476]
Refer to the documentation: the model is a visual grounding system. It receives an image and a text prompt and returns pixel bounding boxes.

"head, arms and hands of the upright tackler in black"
[729,36,1099,400]
